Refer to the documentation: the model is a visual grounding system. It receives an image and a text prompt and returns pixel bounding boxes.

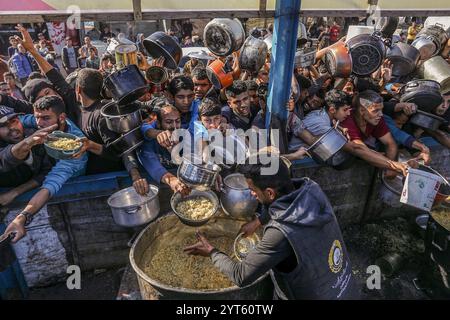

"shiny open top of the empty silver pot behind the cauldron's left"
[107,184,159,209]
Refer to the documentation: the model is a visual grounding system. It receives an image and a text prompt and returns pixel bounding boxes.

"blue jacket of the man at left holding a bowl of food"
[19,114,88,197]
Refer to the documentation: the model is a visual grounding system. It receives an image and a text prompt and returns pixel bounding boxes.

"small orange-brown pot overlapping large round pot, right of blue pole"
[323,46,352,78]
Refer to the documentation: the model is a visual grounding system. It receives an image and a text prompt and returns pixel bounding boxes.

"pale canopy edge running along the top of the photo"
[0,0,450,23]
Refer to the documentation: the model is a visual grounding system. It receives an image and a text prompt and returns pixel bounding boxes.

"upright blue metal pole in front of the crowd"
[266,0,301,153]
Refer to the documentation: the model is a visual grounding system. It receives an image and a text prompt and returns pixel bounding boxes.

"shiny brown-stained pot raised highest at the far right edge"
[412,25,448,60]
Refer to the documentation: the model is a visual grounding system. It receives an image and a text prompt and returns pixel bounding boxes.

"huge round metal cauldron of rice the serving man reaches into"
[130,214,273,300]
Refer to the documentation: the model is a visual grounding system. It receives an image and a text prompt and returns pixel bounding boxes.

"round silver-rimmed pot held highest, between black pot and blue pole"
[203,18,245,57]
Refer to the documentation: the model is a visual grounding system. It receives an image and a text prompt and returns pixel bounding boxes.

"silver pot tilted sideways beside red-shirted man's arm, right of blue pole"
[307,127,347,163]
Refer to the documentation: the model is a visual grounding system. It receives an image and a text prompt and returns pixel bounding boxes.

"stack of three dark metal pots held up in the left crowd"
[101,64,148,156]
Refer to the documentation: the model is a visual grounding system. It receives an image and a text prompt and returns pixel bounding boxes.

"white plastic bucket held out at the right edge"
[400,168,443,212]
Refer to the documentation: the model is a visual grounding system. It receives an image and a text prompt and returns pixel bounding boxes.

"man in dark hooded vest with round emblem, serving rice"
[184,161,358,299]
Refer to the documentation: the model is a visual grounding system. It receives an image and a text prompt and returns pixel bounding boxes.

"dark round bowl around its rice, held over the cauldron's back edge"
[170,190,219,227]
